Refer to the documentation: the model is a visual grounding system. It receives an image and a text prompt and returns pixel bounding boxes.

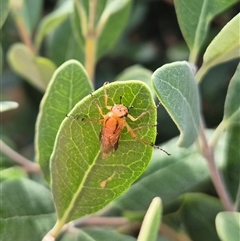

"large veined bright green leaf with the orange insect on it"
[51,81,156,227]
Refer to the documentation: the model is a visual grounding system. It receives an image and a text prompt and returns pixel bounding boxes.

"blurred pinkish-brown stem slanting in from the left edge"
[0,140,40,173]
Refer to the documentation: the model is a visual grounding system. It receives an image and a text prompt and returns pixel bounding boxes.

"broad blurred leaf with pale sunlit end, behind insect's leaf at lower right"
[112,131,226,210]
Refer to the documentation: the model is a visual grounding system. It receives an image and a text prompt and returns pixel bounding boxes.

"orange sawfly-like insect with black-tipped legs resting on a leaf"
[68,83,170,159]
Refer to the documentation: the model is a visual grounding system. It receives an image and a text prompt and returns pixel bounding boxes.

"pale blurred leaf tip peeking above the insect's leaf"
[115,64,155,96]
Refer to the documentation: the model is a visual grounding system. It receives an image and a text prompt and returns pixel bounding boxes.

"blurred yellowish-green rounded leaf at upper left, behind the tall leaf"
[8,43,56,91]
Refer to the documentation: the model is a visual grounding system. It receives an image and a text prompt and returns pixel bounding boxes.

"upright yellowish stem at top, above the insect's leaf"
[85,0,98,84]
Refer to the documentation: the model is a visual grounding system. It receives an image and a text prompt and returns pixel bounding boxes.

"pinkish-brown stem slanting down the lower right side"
[200,121,234,211]
